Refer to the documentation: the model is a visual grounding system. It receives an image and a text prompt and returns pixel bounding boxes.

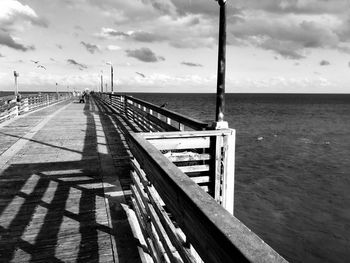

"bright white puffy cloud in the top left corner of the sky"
[0,0,48,31]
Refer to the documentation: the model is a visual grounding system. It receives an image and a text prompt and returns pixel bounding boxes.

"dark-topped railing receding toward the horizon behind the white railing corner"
[96,93,208,132]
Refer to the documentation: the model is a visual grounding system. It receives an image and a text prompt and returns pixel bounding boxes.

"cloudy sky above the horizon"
[0,0,350,93]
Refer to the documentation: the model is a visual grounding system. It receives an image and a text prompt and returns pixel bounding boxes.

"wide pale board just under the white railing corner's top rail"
[148,137,210,150]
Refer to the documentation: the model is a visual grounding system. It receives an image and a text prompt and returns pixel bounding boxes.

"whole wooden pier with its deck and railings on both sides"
[0,93,286,262]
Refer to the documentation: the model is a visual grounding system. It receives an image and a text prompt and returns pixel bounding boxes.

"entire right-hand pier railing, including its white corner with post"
[95,93,286,263]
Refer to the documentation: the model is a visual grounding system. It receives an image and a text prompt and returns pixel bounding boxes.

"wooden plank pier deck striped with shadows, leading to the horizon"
[0,100,141,262]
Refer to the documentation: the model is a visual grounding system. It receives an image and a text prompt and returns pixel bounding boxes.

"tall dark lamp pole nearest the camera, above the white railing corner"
[216,0,227,126]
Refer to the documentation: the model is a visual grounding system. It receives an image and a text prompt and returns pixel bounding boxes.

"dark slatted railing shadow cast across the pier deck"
[0,98,139,262]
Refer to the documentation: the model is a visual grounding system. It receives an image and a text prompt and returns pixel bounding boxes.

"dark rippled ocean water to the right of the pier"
[130,94,350,262]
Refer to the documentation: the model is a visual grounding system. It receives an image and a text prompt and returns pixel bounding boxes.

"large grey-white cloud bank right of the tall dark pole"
[231,12,344,59]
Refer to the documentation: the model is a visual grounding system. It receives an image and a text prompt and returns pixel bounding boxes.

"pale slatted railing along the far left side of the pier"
[0,93,71,123]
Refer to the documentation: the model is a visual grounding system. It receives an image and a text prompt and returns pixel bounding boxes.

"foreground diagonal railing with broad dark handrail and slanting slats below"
[128,132,286,263]
